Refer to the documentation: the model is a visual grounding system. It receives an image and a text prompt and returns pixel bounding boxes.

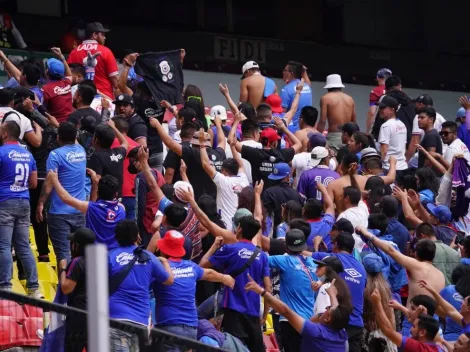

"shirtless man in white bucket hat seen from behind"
[317,74,356,152]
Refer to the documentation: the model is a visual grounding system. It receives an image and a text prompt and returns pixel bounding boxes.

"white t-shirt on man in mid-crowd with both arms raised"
[214,172,249,231]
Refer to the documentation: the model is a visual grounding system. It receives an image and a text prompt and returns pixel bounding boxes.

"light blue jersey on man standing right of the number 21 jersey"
[46,144,86,214]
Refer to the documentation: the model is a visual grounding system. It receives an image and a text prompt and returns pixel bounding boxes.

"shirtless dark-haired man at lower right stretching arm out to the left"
[356,226,445,331]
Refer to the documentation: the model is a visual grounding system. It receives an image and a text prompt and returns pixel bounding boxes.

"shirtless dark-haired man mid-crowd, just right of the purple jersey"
[327,153,367,214]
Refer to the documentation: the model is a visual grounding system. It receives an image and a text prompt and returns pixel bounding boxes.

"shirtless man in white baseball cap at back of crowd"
[240,61,277,109]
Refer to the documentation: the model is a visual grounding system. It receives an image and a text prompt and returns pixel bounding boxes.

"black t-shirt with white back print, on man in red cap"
[242,145,295,189]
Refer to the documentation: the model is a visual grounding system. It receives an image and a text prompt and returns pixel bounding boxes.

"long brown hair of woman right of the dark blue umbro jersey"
[363,272,395,331]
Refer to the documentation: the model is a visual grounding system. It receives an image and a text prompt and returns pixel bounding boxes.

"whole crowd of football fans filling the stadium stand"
[0,23,470,352]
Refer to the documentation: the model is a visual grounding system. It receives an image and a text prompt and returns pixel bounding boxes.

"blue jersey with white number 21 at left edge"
[0,142,36,202]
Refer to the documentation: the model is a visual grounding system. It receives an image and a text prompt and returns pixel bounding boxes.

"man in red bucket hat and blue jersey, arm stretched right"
[153,230,235,351]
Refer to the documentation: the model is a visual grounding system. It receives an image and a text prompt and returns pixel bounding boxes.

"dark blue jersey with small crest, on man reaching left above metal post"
[86,200,126,251]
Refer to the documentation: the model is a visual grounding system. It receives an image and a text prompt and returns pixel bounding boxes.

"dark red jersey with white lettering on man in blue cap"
[42,78,75,122]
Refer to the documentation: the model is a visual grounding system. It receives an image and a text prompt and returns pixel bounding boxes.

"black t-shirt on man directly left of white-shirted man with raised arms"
[183,145,226,201]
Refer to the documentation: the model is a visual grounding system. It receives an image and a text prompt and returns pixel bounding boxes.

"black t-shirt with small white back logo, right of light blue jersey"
[88,147,126,195]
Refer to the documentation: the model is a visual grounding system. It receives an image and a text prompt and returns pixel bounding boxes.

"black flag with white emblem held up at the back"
[135,50,184,104]
